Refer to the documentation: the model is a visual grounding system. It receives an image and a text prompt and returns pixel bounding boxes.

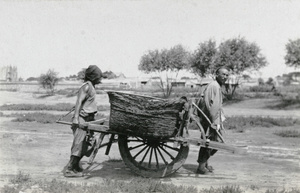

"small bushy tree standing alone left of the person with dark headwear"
[39,70,59,95]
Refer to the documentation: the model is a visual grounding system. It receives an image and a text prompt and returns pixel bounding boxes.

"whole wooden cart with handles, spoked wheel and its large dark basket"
[57,91,246,178]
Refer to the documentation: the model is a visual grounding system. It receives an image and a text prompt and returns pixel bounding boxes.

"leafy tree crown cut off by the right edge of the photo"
[284,39,300,68]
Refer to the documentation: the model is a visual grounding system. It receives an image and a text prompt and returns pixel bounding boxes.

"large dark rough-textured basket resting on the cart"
[108,91,184,138]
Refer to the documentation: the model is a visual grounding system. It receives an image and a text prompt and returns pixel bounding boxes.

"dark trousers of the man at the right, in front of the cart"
[197,121,219,164]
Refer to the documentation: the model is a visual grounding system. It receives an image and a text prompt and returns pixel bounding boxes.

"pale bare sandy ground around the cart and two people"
[0,92,300,192]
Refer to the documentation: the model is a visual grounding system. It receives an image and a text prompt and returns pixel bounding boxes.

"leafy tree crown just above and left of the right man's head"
[191,40,217,77]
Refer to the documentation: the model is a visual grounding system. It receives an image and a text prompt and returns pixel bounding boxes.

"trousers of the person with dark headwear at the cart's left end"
[71,115,95,157]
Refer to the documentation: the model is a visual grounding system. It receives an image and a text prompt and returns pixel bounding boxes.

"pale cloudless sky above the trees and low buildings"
[0,0,300,79]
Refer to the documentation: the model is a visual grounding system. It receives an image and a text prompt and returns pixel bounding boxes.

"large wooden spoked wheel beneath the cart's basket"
[118,135,189,178]
